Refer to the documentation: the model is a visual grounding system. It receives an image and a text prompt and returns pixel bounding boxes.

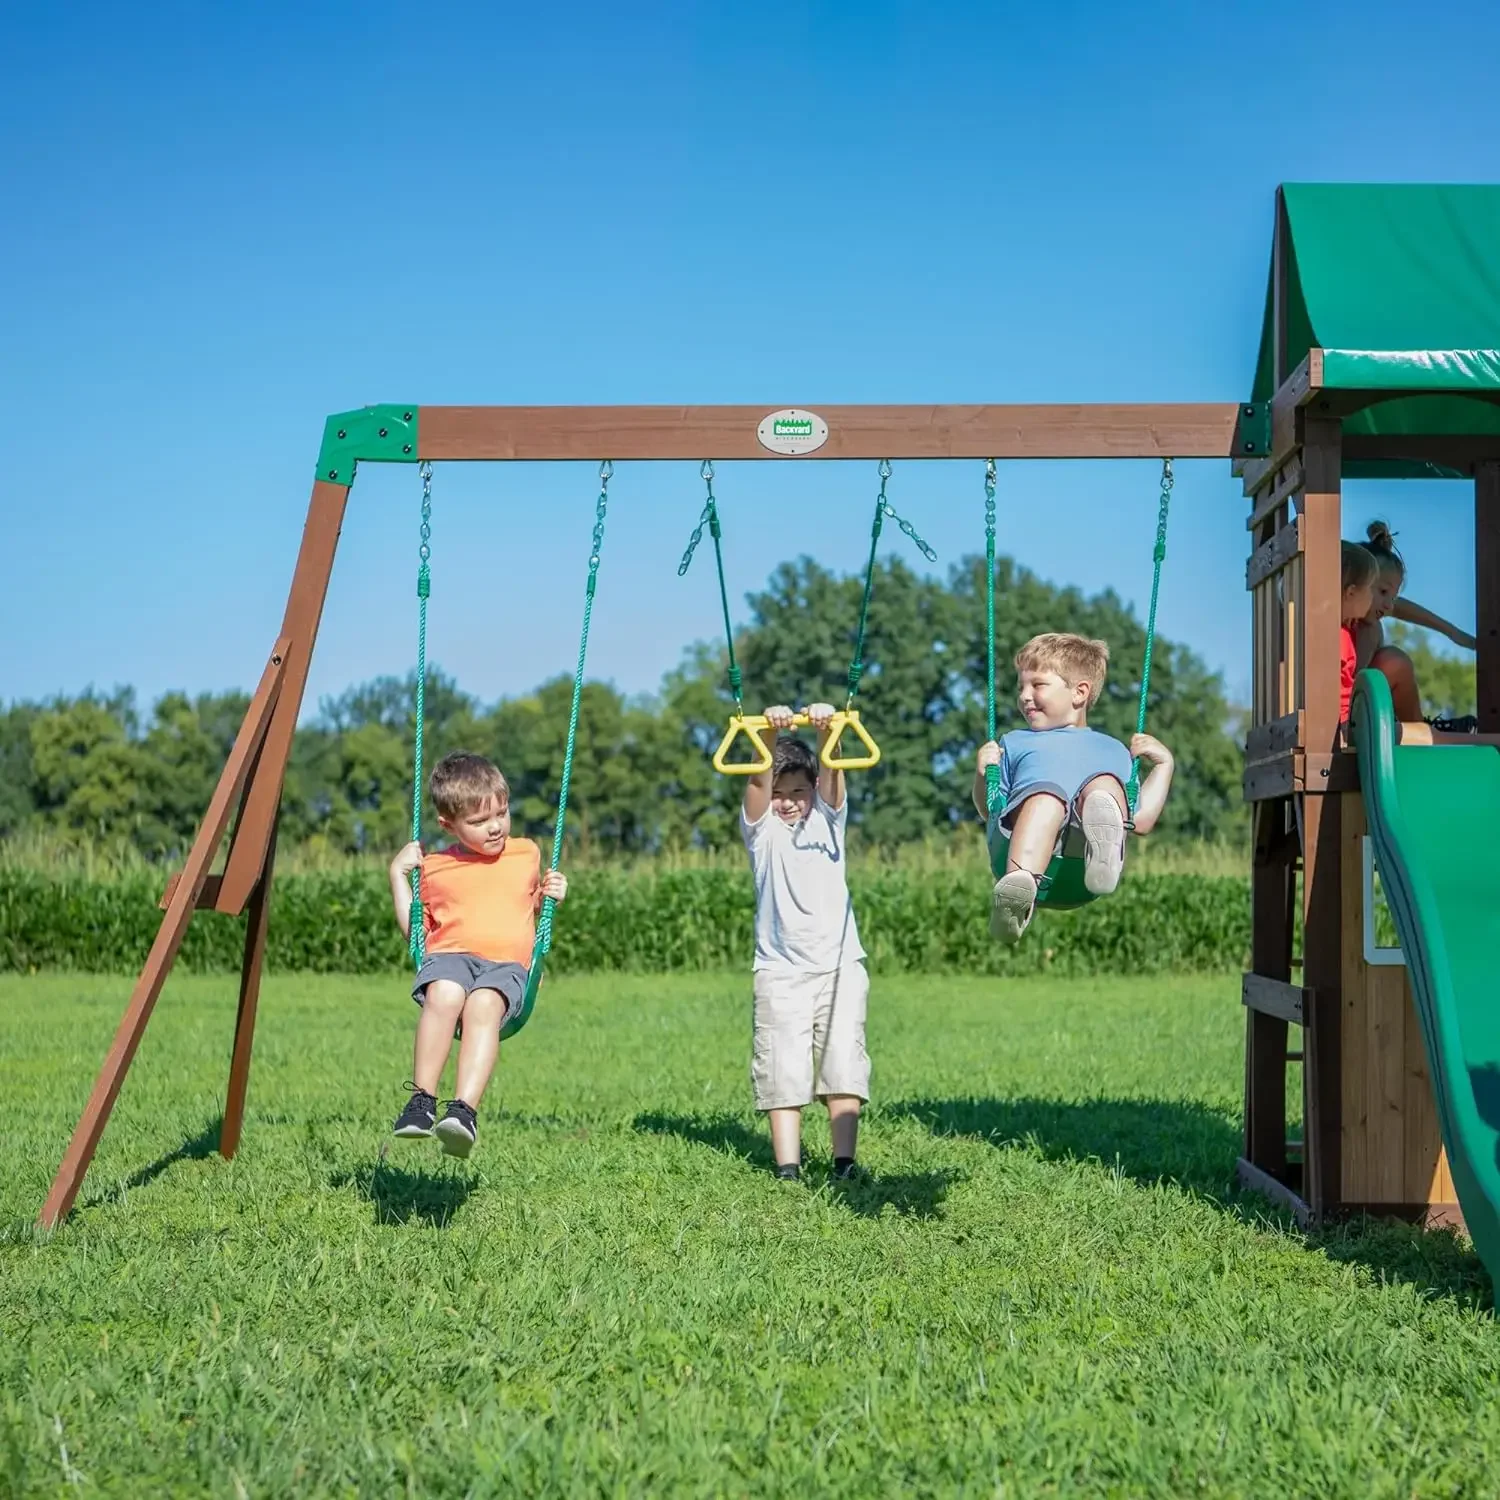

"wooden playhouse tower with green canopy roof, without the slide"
[1236,186,1500,1224]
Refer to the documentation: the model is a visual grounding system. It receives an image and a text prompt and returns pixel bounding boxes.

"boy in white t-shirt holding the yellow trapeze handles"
[740,704,870,1181]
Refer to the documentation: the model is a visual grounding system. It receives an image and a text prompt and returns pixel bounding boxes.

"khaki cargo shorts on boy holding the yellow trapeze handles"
[750,963,870,1110]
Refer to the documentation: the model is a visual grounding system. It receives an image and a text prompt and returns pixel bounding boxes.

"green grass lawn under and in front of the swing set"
[0,975,1500,1497]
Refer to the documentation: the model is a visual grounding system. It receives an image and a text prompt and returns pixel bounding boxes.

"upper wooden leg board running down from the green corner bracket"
[216,480,350,915]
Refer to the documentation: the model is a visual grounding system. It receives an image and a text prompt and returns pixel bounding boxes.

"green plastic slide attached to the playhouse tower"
[1350,671,1500,1284]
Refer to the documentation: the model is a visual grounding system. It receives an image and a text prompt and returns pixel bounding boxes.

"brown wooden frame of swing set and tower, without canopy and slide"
[41,189,1500,1254]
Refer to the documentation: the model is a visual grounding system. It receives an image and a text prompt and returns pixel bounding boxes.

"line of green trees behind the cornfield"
[0,558,1244,860]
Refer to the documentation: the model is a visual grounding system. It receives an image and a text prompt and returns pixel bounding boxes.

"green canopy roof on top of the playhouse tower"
[1251,183,1500,474]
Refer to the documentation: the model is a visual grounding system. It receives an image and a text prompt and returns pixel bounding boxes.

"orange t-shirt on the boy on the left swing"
[422,839,542,965]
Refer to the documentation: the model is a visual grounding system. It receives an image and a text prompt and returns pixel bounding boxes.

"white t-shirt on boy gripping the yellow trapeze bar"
[740,792,864,974]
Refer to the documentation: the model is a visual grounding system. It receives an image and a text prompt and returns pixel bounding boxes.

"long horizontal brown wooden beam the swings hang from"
[419,402,1239,462]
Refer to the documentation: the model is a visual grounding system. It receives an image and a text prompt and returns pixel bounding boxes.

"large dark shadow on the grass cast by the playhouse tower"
[881,1098,1493,1307]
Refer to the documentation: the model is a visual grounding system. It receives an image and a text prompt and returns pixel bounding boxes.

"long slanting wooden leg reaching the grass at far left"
[41,636,291,1229]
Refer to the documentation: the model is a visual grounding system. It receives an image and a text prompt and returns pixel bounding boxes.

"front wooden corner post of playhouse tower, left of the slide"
[1299,419,1344,1218]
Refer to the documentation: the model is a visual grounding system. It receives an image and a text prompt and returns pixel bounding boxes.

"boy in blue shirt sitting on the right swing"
[974,635,1173,942]
